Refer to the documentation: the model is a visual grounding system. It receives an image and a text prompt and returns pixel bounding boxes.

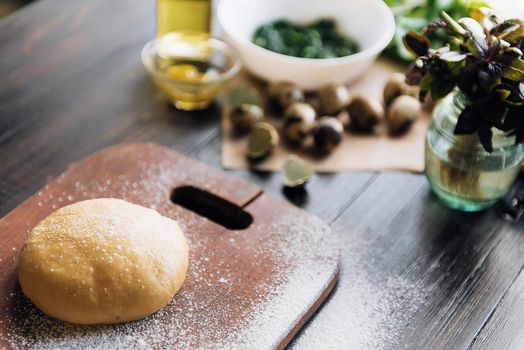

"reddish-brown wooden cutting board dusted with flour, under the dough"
[0,144,339,349]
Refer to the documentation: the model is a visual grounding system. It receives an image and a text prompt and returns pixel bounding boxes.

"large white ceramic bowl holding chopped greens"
[218,0,395,90]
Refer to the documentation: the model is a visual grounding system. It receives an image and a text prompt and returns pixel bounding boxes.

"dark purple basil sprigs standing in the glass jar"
[403,9,524,152]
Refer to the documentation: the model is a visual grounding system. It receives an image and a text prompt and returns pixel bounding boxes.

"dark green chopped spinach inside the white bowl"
[253,18,359,58]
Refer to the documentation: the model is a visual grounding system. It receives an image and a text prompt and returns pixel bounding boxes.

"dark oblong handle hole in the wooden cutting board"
[171,186,253,230]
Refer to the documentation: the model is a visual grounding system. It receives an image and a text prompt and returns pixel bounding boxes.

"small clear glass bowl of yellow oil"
[142,31,241,111]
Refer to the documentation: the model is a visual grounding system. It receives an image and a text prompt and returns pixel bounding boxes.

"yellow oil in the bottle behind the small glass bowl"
[156,0,211,36]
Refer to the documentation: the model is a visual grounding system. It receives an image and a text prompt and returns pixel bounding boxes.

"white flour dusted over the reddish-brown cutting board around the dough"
[0,146,339,350]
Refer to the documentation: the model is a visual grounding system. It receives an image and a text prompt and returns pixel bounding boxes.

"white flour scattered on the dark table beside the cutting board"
[290,223,429,350]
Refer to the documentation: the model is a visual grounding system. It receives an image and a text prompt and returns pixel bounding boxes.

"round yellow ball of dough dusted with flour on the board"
[18,198,188,324]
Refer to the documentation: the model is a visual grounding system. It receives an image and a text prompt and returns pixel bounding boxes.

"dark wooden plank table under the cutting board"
[0,0,524,349]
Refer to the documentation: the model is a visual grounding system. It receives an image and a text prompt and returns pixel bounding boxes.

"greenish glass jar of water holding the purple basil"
[424,91,524,211]
